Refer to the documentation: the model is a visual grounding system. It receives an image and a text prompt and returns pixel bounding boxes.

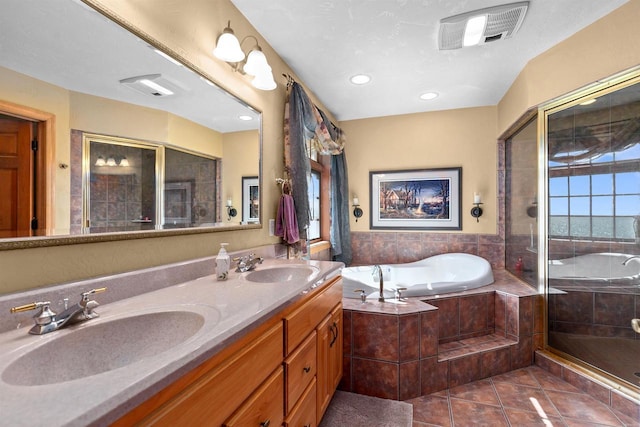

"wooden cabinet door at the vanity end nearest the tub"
[316,303,342,424]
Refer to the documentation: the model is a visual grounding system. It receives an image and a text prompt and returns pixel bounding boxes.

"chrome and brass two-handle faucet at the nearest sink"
[10,288,107,335]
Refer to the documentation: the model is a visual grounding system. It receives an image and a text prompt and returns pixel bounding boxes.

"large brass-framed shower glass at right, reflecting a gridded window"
[546,79,640,390]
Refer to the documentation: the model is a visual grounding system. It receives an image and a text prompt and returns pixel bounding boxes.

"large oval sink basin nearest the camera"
[2,311,212,386]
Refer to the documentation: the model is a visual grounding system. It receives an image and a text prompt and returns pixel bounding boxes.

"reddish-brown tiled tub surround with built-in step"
[340,270,543,400]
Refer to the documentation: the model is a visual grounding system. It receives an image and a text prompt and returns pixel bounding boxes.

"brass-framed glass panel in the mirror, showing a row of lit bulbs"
[83,140,157,233]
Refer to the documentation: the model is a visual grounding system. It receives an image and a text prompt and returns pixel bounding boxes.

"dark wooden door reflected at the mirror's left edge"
[0,117,33,238]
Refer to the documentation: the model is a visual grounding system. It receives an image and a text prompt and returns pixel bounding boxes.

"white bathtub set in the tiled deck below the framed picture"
[342,253,493,298]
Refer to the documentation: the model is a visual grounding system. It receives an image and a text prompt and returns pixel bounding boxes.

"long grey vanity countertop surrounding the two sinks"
[0,249,342,426]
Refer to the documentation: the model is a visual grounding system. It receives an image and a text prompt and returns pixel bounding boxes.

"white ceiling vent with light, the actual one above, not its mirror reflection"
[438,1,529,50]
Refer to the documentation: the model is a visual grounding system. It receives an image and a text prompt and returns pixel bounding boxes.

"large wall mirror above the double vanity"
[0,0,261,249]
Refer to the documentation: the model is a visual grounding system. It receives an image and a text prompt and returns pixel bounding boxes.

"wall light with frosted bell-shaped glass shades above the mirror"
[213,21,278,90]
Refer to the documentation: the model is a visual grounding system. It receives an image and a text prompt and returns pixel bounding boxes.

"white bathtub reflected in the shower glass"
[549,252,640,282]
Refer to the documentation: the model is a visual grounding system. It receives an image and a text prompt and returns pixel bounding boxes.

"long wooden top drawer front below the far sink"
[284,278,342,356]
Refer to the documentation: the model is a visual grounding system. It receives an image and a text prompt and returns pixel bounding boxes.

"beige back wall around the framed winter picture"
[340,107,498,234]
